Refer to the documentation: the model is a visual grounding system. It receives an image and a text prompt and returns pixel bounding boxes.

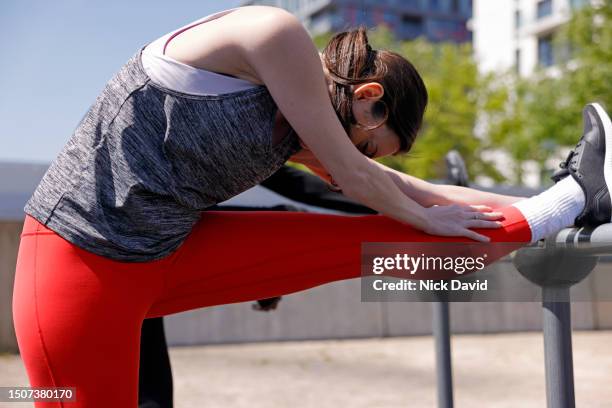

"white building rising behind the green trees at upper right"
[470,0,587,76]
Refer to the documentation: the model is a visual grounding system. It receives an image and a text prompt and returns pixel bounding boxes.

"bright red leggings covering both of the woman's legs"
[13,206,531,408]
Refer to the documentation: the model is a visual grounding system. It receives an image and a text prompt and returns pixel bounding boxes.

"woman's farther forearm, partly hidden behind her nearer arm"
[373,160,526,208]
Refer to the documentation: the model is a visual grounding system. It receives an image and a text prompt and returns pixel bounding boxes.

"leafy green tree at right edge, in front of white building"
[488,2,612,185]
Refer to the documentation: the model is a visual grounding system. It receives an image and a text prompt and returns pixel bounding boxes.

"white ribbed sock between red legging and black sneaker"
[512,175,585,242]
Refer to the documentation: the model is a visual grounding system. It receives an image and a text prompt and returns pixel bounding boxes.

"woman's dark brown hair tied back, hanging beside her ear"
[322,26,428,153]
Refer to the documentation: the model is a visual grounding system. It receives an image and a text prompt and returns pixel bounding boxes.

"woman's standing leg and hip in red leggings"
[13,216,163,408]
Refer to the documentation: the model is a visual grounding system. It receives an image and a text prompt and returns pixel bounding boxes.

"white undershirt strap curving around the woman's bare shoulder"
[142,7,259,95]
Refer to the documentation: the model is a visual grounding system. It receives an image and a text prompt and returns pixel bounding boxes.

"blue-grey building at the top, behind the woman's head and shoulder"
[242,0,472,43]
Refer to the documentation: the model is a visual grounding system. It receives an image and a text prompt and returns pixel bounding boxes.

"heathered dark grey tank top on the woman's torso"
[24,45,300,262]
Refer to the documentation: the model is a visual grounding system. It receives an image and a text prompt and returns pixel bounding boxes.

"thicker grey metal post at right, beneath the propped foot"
[542,286,576,408]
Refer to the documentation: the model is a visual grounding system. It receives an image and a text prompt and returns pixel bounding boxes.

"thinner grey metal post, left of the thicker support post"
[433,301,453,408]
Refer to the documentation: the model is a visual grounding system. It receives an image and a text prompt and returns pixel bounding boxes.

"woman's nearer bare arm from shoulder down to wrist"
[241,9,427,223]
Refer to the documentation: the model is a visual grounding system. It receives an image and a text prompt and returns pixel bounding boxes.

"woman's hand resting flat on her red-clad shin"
[423,204,503,242]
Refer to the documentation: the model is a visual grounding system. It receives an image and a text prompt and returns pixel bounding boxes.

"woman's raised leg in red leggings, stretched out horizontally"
[148,206,531,317]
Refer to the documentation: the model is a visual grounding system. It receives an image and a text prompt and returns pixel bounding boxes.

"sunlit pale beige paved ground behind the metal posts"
[0,331,612,408]
